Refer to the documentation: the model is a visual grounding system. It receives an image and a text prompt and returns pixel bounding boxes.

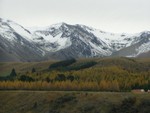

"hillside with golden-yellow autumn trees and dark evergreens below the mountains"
[0,57,150,91]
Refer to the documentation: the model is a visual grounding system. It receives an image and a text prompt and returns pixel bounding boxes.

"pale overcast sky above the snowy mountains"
[0,0,150,33]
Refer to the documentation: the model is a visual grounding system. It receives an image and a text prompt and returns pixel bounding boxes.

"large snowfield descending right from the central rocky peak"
[80,25,134,51]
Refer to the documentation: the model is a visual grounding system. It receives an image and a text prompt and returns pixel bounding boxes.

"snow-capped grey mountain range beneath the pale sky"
[0,18,150,62]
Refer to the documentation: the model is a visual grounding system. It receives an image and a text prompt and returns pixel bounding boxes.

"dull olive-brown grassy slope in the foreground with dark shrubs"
[0,91,150,113]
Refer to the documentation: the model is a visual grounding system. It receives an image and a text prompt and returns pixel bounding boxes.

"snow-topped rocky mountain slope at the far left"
[0,19,42,61]
